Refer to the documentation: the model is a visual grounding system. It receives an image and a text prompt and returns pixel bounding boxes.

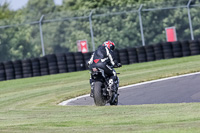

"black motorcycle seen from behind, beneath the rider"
[91,68,119,106]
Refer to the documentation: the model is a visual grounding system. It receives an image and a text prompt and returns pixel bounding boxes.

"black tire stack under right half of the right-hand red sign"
[172,42,183,58]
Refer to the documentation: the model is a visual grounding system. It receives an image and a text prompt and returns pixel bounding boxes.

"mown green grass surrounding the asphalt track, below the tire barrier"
[0,56,200,133]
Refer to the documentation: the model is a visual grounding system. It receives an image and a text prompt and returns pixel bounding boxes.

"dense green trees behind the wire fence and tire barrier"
[0,0,200,62]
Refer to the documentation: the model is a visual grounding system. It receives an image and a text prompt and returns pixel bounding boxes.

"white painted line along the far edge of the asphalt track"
[58,72,200,106]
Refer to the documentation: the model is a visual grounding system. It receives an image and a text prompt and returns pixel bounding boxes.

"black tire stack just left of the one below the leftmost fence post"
[31,58,41,77]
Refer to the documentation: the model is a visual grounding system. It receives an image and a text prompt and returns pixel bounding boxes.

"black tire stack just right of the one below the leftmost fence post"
[46,54,58,74]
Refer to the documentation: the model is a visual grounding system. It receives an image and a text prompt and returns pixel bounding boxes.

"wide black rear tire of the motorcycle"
[94,81,106,106]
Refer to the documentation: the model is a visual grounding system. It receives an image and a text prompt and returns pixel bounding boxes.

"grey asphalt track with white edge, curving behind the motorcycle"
[60,72,200,106]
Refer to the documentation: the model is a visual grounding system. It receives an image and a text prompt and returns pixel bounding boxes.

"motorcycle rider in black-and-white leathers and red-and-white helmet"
[88,41,121,97]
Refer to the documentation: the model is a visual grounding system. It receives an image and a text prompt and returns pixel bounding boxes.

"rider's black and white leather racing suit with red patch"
[88,45,118,91]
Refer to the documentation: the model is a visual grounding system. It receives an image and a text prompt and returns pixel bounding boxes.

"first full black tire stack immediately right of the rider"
[119,49,129,65]
